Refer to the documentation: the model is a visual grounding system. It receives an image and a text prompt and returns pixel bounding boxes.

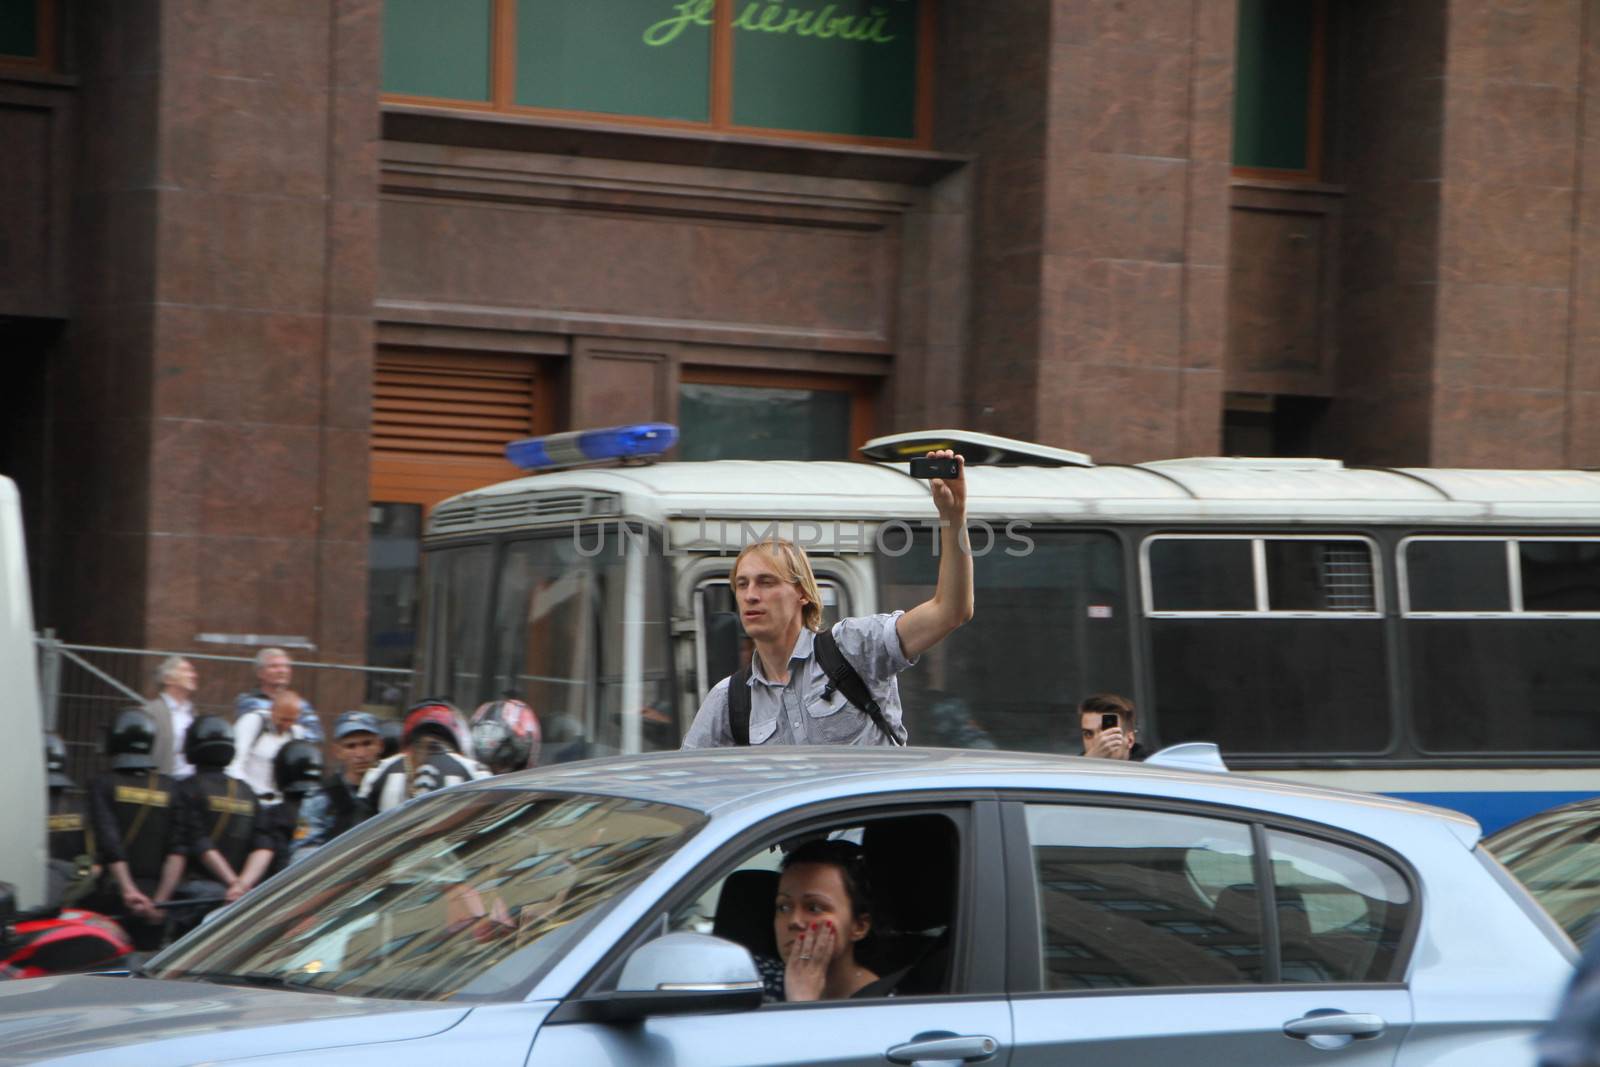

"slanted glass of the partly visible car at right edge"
[1483,805,1600,945]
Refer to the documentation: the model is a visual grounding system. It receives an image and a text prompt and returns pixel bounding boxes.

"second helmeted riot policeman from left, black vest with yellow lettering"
[90,707,189,949]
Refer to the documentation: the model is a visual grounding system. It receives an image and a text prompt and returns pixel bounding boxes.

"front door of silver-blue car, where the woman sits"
[530,801,1011,1067]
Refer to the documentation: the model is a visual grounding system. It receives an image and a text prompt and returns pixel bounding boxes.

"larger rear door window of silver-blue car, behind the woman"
[1027,805,1262,990]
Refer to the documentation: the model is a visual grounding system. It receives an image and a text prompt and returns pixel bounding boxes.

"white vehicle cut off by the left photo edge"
[0,477,46,909]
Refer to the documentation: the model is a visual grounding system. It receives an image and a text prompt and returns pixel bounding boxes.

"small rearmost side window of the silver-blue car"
[1267,830,1411,982]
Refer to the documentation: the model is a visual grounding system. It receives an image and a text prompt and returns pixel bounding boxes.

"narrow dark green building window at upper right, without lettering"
[1234,0,1328,181]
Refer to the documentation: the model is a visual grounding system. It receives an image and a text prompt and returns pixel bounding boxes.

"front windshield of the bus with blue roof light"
[424,525,678,763]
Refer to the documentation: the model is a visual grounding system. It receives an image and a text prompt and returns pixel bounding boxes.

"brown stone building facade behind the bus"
[0,0,1600,662]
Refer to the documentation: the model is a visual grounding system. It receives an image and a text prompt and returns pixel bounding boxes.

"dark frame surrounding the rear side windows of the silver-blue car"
[998,790,1426,998]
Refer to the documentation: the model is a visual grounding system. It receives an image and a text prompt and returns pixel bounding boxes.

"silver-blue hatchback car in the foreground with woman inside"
[0,749,1574,1067]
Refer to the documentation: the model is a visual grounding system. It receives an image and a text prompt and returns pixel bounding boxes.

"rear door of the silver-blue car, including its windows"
[1005,800,1414,1067]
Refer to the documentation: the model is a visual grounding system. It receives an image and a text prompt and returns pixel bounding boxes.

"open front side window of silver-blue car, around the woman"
[667,813,960,1001]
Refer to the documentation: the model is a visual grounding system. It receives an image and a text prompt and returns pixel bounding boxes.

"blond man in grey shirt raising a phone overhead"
[683,450,973,749]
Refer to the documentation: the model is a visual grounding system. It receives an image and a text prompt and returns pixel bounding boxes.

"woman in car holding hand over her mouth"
[757,840,893,1001]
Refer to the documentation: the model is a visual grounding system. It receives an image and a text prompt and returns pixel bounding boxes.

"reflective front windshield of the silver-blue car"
[144,790,704,1000]
